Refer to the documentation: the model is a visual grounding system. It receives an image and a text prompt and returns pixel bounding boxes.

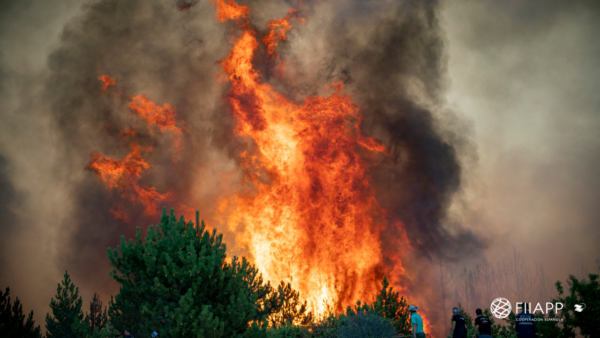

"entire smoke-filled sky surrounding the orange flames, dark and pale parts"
[0,0,600,336]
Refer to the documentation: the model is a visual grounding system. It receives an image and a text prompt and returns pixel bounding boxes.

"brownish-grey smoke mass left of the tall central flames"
[40,0,237,302]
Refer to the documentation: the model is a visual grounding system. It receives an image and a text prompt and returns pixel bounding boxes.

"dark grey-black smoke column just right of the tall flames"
[316,2,485,257]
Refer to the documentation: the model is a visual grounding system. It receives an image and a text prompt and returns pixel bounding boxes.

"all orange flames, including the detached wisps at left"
[86,1,424,315]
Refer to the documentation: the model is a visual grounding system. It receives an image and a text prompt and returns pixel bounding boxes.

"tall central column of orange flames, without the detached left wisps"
[213,0,404,314]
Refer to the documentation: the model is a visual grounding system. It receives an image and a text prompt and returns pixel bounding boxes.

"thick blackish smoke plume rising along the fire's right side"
[284,1,486,258]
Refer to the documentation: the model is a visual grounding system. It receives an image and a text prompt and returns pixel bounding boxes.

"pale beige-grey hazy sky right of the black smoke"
[443,1,600,280]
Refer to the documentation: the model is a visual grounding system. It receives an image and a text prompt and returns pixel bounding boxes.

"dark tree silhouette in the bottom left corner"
[0,288,42,338]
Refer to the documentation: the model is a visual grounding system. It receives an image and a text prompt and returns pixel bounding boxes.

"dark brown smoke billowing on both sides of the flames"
[2,0,483,334]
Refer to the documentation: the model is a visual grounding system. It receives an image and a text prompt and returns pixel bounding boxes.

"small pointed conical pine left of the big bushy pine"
[46,272,85,338]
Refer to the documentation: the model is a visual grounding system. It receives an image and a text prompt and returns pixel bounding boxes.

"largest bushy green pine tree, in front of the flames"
[108,210,279,338]
